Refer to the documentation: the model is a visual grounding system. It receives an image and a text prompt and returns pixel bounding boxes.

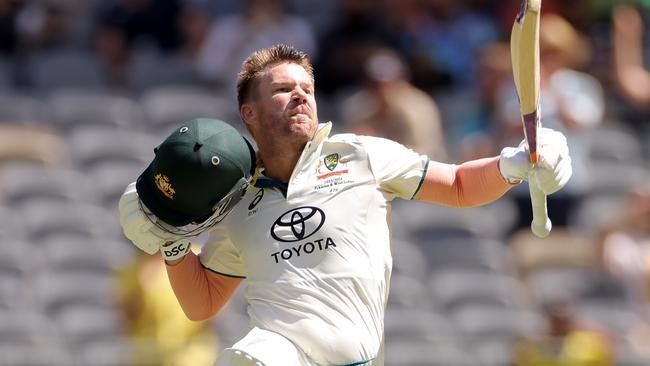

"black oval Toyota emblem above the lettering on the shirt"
[271,206,325,243]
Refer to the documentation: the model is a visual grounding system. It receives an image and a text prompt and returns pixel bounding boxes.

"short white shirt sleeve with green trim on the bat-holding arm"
[360,136,429,200]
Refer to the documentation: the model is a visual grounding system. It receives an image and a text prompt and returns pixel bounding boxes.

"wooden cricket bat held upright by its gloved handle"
[510,0,552,238]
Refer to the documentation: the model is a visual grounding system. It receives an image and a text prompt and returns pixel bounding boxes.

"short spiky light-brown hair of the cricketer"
[237,44,314,107]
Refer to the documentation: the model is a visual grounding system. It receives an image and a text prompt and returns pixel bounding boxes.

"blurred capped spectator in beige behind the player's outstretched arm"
[342,49,447,161]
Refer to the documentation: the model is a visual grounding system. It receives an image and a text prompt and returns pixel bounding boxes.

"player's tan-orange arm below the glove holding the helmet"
[167,251,241,320]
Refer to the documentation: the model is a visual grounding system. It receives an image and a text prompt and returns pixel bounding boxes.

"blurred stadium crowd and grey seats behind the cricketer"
[0,0,650,366]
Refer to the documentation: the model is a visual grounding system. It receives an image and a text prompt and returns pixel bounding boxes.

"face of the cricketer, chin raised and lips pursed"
[243,63,318,145]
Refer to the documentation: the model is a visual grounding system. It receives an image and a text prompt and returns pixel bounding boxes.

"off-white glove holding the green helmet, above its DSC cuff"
[119,182,180,254]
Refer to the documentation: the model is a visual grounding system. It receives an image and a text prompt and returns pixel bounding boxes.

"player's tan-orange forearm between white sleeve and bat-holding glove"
[416,157,513,208]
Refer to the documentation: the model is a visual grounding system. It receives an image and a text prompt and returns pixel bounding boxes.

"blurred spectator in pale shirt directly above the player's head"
[196,0,316,90]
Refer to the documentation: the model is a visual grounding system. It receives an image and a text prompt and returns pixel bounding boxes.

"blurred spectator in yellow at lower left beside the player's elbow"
[118,253,218,366]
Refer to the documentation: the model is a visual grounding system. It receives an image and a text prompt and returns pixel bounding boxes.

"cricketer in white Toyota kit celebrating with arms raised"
[120,45,571,366]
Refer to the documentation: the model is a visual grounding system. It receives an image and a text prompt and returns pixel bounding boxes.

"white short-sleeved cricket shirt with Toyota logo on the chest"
[200,123,429,365]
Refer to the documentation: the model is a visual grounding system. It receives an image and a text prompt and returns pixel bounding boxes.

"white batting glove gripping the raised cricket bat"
[499,128,573,195]
